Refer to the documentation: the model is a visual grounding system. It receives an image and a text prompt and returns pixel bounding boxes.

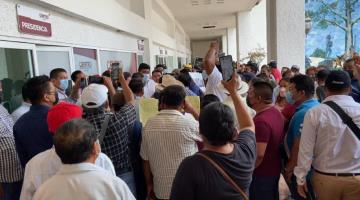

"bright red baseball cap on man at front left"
[47,102,82,134]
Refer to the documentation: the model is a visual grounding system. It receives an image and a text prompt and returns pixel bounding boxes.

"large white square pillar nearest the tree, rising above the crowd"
[267,0,305,72]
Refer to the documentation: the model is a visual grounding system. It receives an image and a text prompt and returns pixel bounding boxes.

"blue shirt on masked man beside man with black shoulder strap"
[286,99,320,151]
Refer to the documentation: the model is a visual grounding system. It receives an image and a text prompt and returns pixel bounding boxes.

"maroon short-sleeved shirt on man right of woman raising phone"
[253,107,284,177]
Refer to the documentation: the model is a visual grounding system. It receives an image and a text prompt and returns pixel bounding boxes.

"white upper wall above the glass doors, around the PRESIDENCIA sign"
[0,0,190,65]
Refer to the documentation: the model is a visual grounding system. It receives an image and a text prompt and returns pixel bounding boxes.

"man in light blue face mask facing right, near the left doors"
[50,68,81,103]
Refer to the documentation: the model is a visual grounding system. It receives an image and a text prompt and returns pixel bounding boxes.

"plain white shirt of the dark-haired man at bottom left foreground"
[34,163,135,200]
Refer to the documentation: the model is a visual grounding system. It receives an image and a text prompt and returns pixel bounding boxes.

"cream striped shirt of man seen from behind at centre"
[140,110,201,199]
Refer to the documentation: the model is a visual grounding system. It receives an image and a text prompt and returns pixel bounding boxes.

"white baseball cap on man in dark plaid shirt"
[81,83,108,108]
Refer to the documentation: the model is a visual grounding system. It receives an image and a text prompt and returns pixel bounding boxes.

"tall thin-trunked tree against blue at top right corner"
[306,0,360,57]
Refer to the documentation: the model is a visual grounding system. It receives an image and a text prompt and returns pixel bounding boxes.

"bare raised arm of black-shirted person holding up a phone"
[222,73,255,133]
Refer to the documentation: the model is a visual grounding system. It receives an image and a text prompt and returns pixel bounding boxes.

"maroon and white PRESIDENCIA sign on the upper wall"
[17,4,52,37]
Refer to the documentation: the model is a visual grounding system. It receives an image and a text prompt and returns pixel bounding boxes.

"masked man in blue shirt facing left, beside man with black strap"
[284,75,319,200]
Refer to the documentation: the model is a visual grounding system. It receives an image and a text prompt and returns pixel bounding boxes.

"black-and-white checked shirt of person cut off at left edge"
[0,105,23,183]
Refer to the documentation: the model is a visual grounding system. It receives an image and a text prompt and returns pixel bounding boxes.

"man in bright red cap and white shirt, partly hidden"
[20,102,115,200]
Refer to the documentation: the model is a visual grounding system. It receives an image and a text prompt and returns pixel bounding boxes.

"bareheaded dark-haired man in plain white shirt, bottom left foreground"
[33,119,135,200]
